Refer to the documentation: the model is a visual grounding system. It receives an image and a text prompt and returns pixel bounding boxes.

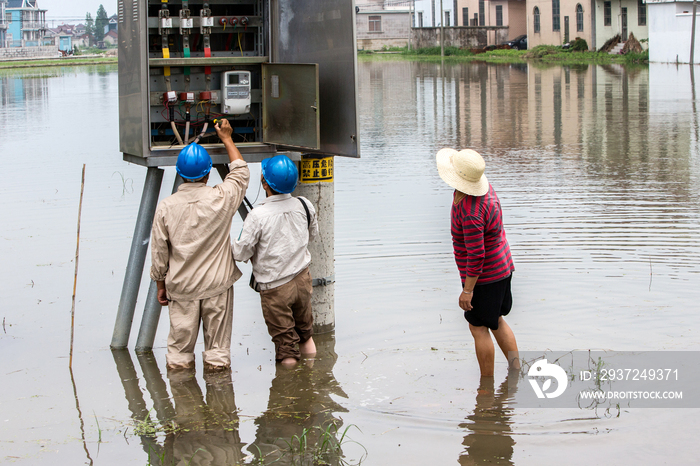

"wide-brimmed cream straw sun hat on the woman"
[435,149,489,196]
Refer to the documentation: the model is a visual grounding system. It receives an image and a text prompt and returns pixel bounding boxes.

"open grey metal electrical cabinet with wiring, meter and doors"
[118,0,359,166]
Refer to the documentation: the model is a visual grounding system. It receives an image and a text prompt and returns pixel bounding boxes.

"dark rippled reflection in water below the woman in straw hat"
[459,371,518,466]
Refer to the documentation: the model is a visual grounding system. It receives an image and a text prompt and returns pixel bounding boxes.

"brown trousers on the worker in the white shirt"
[260,268,314,361]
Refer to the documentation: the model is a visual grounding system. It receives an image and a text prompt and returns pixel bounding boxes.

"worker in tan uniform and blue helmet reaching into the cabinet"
[151,120,250,370]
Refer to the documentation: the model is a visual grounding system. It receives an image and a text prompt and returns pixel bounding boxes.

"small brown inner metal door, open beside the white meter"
[262,63,321,151]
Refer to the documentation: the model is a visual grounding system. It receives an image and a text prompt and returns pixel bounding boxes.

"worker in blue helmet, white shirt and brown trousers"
[233,155,318,365]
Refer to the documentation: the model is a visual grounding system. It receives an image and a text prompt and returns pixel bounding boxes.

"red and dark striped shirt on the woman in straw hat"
[450,185,515,285]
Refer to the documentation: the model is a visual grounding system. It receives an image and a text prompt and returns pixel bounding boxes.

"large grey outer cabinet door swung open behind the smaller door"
[271,0,360,157]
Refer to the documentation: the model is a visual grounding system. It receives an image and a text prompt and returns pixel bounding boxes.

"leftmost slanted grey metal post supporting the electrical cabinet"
[110,167,163,349]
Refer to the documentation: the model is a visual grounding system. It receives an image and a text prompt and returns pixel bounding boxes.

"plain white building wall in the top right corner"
[647,2,700,63]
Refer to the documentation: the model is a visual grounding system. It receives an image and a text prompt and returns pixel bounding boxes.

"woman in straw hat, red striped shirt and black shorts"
[436,149,519,377]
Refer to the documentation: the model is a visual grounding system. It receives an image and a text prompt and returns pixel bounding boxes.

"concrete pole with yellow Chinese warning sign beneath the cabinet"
[293,155,335,334]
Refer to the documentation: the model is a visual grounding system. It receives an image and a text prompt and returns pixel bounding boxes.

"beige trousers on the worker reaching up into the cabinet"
[165,287,233,368]
